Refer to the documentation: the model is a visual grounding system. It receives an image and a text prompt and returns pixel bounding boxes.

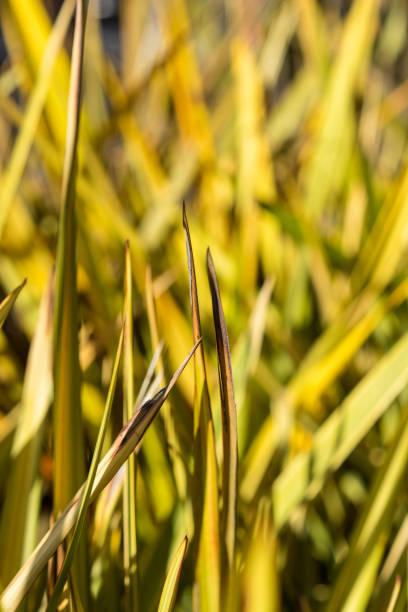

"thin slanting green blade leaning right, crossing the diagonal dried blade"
[48,328,126,612]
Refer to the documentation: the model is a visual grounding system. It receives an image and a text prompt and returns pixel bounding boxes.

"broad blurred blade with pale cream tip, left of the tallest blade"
[0,278,53,584]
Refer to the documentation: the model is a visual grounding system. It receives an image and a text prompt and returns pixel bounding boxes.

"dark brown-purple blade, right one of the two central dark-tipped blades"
[207,249,238,570]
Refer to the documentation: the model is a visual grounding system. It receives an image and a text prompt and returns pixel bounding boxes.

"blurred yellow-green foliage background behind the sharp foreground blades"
[0,0,408,610]
